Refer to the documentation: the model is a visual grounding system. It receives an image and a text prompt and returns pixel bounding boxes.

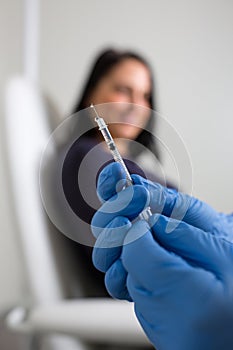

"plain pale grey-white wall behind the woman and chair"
[0,0,233,308]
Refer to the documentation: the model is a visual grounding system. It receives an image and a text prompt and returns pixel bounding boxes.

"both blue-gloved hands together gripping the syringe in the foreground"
[93,164,233,350]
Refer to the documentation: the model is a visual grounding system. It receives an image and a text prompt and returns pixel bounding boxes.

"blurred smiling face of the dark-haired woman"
[89,58,152,140]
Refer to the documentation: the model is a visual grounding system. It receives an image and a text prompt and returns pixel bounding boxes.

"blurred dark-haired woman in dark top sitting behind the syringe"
[62,49,164,297]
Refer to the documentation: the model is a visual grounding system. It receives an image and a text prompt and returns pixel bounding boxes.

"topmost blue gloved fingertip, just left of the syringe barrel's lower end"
[97,162,126,202]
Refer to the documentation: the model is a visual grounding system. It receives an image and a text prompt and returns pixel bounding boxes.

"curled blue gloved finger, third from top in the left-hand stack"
[92,216,131,272]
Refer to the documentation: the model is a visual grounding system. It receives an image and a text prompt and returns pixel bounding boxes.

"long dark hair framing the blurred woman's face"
[72,49,160,159]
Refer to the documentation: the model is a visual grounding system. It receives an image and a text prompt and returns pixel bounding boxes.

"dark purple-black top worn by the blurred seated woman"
[62,135,171,297]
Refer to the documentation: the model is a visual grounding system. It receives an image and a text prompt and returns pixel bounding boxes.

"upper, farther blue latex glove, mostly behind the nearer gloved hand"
[94,163,233,242]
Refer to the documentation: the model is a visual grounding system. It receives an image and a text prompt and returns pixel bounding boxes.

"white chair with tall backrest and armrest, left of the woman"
[5,77,150,350]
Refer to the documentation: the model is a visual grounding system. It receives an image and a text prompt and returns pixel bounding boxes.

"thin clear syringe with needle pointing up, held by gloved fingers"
[90,104,152,220]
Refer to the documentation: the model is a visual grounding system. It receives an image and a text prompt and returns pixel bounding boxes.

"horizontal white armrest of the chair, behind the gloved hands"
[6,298,149,345]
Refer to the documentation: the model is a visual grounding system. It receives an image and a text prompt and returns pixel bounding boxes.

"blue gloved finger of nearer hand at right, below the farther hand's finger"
[151,215,233,279]
